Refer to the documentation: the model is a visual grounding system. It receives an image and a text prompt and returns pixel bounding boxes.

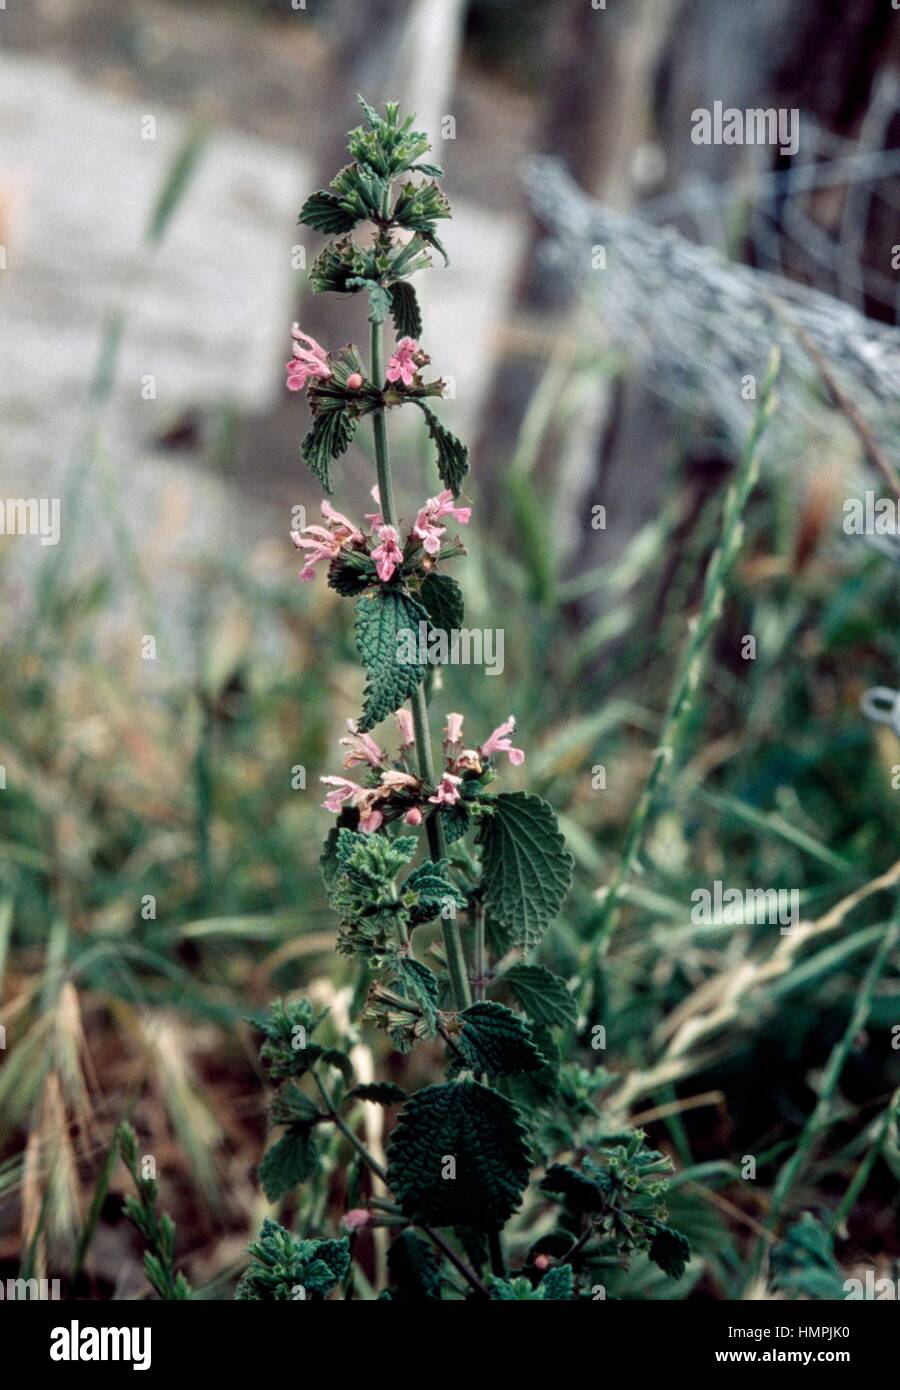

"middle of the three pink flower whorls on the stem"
[291,488,472,584]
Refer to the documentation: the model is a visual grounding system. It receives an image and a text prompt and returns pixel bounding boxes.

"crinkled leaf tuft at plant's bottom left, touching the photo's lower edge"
[235,1219,351,1302]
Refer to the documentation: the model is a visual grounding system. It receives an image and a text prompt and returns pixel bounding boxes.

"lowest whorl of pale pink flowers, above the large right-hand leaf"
[321,709,524,833]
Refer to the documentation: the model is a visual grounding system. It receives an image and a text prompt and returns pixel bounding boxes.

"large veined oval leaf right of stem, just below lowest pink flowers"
[479,791,574,948]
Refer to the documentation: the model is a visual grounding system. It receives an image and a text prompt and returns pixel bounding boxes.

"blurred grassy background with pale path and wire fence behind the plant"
[0,0,900,1298]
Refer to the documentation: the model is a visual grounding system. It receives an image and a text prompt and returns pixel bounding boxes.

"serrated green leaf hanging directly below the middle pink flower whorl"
[356,588,428,733]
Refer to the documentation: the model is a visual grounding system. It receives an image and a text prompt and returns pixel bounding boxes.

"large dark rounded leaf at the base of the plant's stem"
[388,1081,529,1230]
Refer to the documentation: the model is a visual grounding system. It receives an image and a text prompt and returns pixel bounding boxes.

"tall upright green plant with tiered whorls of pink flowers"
[238,101,689,1301]
